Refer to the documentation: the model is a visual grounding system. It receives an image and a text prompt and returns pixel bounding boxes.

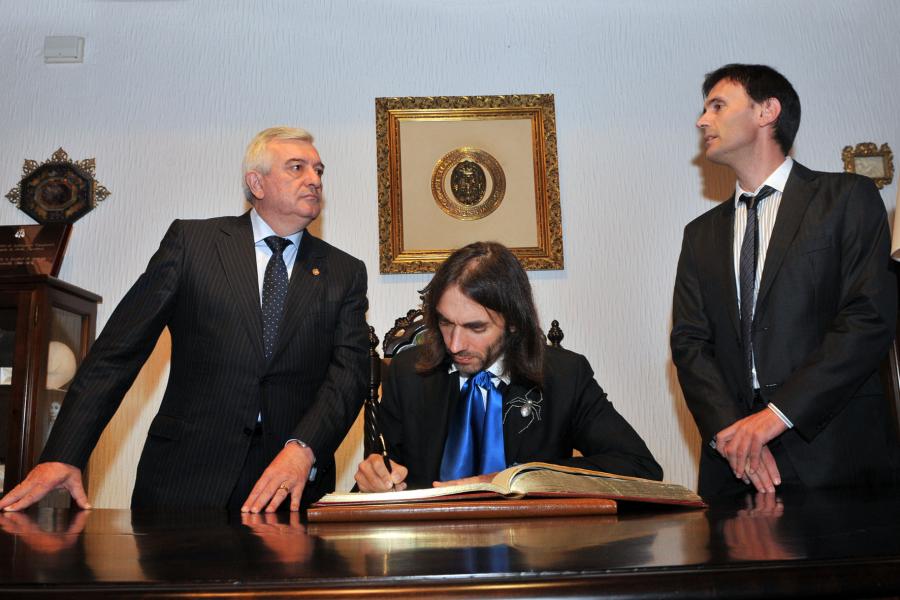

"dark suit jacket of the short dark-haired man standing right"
[671,163,897,495]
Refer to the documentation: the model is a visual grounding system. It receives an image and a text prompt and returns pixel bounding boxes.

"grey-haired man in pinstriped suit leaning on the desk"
[0,127,368,513]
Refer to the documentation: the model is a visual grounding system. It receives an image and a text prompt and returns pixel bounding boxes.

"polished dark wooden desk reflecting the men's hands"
[0,490,900,599]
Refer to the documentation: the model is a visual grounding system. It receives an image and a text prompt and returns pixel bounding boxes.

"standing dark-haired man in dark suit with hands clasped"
[671,64,898,495]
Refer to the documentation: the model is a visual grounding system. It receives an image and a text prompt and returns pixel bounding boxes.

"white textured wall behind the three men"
[0,0,900,507]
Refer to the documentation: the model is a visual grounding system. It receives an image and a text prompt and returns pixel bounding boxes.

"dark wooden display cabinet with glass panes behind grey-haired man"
[0,275,101,506]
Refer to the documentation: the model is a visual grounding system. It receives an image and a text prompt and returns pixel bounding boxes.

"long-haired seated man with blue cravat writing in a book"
[356,242,662,491]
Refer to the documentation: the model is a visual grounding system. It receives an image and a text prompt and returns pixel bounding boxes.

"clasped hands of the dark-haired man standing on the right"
[715,408,787,493]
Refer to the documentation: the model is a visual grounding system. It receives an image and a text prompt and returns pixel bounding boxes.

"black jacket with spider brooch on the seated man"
[378,347,662,487]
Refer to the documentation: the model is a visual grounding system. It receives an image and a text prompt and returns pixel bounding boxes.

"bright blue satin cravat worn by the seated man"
[441,371,506,481]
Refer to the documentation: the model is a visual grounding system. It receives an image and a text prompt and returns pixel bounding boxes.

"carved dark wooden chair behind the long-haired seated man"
[363,308,565,456]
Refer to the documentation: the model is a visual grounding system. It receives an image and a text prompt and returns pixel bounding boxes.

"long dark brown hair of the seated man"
[416,242,546,386]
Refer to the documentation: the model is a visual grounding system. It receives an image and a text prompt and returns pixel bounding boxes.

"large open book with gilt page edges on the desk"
[307,462,706,520]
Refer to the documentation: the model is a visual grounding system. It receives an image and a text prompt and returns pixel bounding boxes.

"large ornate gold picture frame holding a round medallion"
[375,94,563,273]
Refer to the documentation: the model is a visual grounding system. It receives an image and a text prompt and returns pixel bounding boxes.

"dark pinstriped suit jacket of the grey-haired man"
[41,213,368,507]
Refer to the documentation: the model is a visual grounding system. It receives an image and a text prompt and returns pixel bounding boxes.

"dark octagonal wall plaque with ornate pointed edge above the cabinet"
[6,148,110,224]
